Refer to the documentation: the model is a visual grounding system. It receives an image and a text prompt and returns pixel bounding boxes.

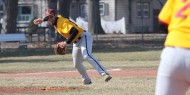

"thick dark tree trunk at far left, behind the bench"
[1,0,18,34]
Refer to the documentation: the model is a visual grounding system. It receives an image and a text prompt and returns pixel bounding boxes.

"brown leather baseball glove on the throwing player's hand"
[54,44,67,55]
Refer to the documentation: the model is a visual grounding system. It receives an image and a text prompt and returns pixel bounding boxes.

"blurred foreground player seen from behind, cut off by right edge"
[155,0,190,95]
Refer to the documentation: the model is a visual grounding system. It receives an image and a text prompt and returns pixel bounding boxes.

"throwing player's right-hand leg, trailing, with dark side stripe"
[81,32,111,81]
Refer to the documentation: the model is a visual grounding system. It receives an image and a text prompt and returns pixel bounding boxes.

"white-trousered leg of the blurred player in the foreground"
[155,47,189,95]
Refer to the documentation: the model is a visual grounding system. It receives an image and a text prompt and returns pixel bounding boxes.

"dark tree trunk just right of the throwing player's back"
[88,0,105,34]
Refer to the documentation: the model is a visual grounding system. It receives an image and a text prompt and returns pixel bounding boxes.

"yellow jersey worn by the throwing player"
[55,15,84,42]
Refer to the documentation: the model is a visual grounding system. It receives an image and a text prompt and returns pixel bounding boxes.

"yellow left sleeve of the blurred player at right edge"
[158,0,175,25]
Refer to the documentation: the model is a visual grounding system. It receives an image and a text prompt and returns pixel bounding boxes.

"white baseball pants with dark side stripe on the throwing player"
[72,32,109,82]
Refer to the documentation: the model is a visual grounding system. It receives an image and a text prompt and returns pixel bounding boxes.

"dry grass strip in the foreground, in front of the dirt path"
[0,77,155,95]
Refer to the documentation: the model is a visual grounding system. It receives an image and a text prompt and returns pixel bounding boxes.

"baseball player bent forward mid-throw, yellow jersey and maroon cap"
[33,9,112,84]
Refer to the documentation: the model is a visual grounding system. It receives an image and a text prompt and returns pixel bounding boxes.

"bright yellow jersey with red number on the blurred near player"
[159,0,190,48]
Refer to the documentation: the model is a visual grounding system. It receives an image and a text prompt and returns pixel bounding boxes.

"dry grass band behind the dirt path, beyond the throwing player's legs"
[0,49,161,73]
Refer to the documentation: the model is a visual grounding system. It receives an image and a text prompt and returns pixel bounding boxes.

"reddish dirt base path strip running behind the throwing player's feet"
[0,69,157,77]
